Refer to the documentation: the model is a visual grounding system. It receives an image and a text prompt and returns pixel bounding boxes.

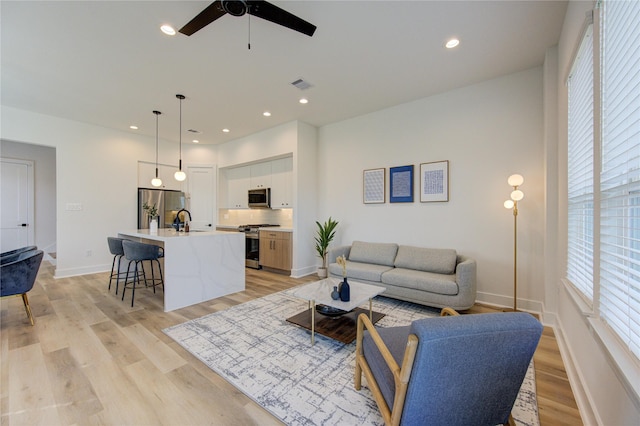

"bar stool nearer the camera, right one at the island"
[122,240,164,307]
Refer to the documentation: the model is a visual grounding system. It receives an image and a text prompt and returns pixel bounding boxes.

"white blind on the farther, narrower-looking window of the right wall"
[567,25,594,303]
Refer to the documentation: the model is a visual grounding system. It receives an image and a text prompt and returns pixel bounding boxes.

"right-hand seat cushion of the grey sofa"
[382,268,458,296]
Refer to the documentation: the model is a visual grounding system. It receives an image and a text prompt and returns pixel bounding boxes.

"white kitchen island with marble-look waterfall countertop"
[118,229,245,312]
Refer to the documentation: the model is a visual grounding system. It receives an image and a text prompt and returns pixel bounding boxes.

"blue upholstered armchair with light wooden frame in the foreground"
[355,312,542,426]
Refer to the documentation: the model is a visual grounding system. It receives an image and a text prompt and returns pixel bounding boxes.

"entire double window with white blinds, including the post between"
[567,0,640,361]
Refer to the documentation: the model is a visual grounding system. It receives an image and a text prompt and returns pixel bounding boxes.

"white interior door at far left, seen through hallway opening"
[0,158,34,252]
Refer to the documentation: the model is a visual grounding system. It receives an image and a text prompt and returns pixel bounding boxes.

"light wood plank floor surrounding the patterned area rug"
[0,262,582,426]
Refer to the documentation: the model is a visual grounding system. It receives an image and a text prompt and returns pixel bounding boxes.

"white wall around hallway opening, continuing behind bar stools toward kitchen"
[0,106,216,277]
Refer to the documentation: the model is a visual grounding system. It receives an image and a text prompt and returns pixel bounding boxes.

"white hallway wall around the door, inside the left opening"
[0,140,56,253]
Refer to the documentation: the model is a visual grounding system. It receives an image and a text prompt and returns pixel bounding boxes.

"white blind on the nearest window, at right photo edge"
[600,1,640,358]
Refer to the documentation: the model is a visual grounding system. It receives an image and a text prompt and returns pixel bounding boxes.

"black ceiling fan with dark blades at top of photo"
[180,0,316,37]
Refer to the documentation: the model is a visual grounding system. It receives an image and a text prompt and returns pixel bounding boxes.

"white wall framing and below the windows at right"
[549,1,640,425]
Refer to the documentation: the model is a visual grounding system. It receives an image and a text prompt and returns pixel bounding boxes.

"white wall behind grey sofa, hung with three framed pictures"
[318,68,544,311]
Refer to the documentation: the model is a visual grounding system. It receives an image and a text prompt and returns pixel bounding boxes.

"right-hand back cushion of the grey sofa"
[395,246,457,274]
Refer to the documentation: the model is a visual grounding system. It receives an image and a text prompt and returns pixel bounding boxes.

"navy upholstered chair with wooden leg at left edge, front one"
[0,250,44,325]
